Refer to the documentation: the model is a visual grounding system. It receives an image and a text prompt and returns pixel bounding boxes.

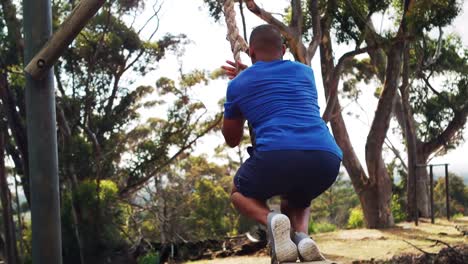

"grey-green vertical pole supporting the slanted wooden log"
[23,0,62,264]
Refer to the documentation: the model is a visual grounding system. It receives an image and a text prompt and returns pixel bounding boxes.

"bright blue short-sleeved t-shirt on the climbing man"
[224,60,343,159]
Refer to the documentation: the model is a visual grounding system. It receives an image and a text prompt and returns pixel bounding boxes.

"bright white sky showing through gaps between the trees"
[129,0,468,182]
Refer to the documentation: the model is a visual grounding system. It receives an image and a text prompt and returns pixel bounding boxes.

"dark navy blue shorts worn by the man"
[234,150,341,208]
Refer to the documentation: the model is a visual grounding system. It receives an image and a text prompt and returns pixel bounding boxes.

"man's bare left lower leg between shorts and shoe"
[231,185,270,226]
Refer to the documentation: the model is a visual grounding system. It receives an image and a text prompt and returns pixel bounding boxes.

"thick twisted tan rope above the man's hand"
[224,0,249,62]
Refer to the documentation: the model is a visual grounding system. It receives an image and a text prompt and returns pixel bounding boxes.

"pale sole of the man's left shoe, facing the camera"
[268,214,299,263]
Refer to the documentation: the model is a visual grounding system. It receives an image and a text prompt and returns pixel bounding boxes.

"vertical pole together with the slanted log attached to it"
[23,0,106,264]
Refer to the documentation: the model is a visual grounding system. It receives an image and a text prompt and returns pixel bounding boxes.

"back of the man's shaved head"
[250,24,283,55]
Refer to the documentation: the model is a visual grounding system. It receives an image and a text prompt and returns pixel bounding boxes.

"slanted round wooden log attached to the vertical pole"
[25,0,106,80]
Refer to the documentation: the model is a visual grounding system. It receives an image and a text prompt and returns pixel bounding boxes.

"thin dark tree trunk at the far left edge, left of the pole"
[0,128,18,264]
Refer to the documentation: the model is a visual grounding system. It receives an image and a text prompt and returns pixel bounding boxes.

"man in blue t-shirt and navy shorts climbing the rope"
[222,25,342,262]
